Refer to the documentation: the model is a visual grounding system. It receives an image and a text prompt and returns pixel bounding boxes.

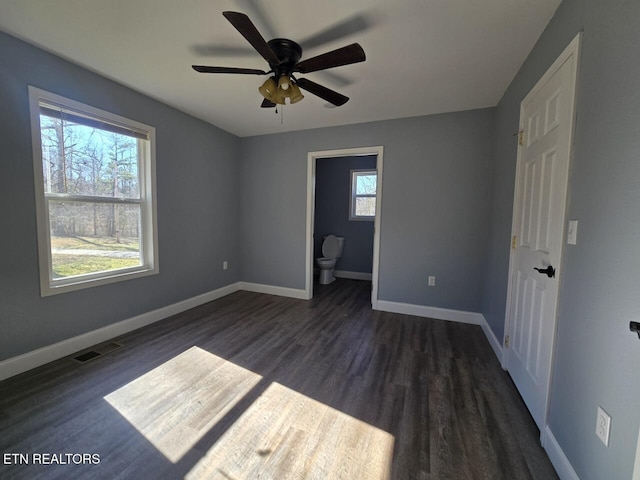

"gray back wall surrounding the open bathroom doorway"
[240,109,493,312]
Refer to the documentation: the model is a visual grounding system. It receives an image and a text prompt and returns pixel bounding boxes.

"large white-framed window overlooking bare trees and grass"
[29,87,158,296]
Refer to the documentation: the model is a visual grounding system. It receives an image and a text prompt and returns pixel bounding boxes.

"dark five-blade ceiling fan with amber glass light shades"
[193,11,366,108]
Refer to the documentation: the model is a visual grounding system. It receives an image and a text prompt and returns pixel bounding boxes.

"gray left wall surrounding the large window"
[0,33,240,360]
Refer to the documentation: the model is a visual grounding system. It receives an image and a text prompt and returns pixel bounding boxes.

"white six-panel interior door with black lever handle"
[505,37,580,432]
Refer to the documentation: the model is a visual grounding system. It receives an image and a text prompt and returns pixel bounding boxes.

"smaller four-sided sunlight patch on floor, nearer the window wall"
[104,346,262,463]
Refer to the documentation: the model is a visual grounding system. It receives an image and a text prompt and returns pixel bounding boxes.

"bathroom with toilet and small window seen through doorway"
[313,155,377,285]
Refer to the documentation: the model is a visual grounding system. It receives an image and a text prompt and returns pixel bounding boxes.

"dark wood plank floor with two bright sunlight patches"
[0,280,557,480]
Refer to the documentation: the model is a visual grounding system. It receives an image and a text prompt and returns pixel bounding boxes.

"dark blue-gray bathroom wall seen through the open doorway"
[313,155,377,273]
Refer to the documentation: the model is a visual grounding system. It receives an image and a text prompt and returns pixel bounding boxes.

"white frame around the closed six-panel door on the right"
[501,32,582,440]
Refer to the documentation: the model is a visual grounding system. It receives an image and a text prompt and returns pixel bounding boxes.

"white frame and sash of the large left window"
[29,86,159,297]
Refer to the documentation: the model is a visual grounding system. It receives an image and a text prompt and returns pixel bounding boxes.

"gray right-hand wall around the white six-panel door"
[483,0,640,480]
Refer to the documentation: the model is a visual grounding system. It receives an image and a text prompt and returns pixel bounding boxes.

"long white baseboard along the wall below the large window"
[0,283,240,380]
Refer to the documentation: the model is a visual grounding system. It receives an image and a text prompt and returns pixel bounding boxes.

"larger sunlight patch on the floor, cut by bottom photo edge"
[185,383,394,480]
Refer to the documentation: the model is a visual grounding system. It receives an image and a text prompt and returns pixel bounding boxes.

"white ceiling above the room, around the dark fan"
[0,0,560,137]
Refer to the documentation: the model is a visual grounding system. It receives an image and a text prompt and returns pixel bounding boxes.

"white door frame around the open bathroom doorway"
[304,146,384,309]
